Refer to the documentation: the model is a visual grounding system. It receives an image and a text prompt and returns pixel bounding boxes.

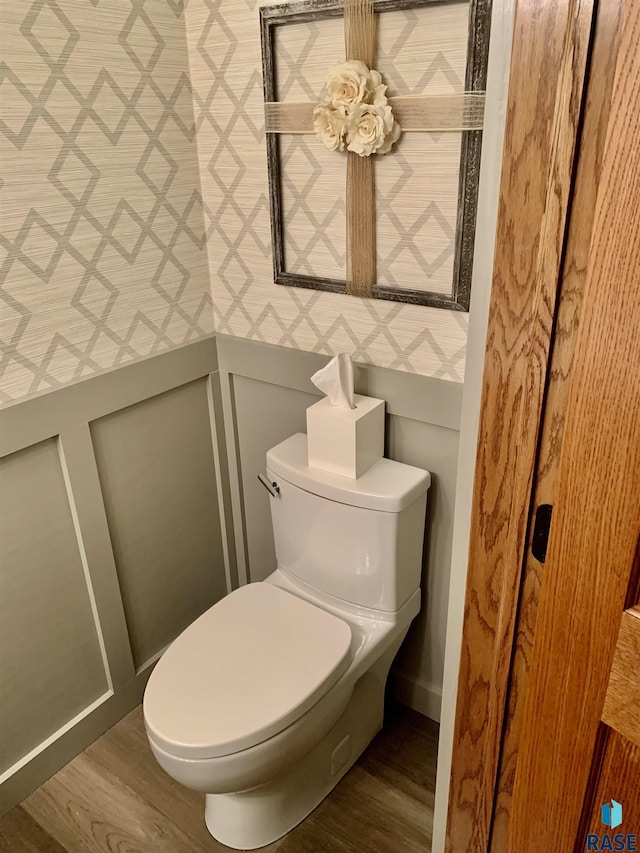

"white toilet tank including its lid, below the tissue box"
[267,433,431,611]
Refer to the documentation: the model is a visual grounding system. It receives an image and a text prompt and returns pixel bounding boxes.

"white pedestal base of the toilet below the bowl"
[205,664,384,850]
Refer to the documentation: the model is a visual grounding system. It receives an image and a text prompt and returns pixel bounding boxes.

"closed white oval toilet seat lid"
[144,583,351,758]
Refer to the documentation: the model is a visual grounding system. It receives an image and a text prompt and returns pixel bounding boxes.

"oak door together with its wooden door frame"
[447,0,640,853]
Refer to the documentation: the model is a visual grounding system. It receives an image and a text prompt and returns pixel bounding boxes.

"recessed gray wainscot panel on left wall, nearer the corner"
[91,378,227,669]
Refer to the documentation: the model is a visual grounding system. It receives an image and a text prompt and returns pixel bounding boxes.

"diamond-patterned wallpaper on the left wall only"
[0,0,213,403]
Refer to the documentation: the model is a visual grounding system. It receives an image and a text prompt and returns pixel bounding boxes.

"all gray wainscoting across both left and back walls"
[0,336,462,813]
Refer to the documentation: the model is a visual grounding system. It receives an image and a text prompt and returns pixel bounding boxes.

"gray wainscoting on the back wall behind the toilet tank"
[217,336,462,719]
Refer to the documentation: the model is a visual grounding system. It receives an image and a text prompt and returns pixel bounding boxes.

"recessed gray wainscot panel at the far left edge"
[0,439,111,771]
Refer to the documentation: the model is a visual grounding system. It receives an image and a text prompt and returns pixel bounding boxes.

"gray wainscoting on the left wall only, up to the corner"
[0,338,229,811]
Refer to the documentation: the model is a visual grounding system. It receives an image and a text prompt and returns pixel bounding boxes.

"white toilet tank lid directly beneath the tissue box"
[267,432,431,512]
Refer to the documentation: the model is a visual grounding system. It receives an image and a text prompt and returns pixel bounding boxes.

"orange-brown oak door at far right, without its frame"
[507,3,640,853]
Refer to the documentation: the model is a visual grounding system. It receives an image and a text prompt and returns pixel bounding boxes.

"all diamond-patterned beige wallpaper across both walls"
[0,0,467,405]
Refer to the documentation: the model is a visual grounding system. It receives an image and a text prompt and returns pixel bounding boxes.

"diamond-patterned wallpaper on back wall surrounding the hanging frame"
[186,0,468,382]
